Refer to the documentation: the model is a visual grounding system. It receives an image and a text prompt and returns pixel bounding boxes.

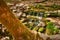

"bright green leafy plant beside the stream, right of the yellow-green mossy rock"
[46,22,59,35]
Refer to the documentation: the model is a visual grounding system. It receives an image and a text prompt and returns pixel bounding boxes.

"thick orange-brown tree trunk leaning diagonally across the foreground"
[0,0,43,40]
